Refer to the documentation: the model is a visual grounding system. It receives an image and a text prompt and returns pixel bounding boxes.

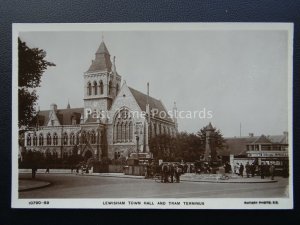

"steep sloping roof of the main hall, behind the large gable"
[128,87,173,122]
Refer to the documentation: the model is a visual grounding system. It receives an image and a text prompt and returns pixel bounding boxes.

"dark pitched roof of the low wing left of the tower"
[38,108,83,126]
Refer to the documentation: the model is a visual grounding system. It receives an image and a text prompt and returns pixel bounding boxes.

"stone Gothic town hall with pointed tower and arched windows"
[25,41,177,160]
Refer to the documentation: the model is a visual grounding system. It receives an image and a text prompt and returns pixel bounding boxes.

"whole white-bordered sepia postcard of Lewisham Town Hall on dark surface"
[12,23,293,209]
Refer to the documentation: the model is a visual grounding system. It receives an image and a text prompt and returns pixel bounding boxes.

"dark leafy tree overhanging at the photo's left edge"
[18,38,55,127]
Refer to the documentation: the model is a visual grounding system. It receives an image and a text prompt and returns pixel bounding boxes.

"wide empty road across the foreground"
[19,174,288,198]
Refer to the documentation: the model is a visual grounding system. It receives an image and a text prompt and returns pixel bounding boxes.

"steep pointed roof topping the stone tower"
[87,41,112,72]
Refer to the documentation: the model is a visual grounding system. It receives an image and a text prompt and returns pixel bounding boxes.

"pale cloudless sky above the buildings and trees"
[19,27,288,137]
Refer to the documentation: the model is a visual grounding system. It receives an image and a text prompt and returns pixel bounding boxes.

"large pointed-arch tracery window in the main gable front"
[113,109,133,143]
